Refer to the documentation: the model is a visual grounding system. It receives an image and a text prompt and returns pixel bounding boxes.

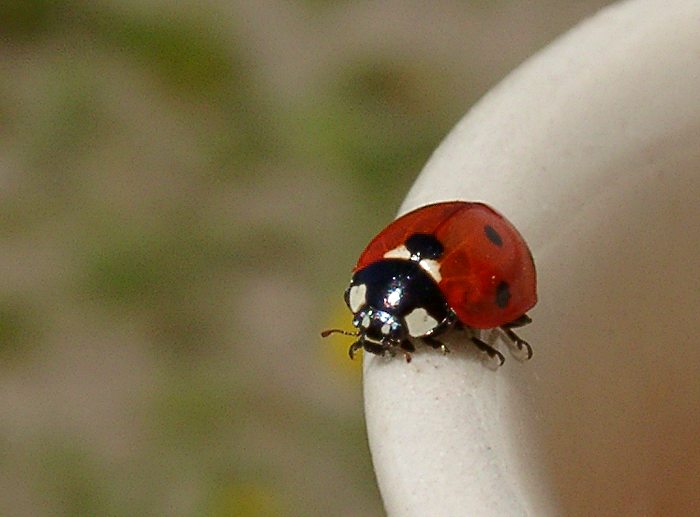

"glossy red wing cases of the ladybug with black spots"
[354,201,537,329]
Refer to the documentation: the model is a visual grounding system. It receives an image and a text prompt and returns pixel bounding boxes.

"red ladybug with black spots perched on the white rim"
[322,201,537,364]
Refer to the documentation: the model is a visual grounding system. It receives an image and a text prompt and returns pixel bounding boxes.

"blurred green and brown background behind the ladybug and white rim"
[0,0,607,516]
